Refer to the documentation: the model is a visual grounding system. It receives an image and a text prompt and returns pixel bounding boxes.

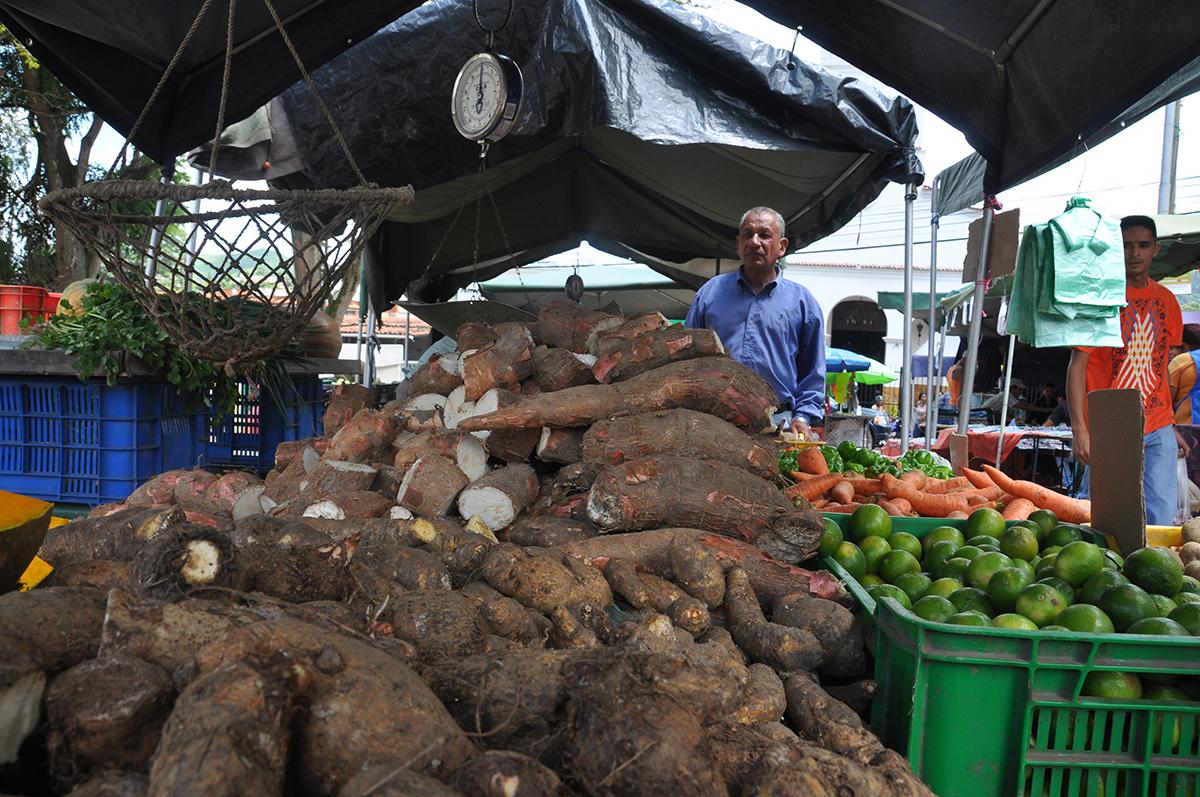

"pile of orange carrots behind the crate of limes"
[784,448,1092,523]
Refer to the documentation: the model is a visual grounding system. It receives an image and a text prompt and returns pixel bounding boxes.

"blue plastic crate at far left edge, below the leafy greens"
[0,374,203,505]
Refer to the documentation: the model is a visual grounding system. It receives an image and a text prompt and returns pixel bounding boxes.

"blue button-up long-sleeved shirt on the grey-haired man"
[685,268,826,423]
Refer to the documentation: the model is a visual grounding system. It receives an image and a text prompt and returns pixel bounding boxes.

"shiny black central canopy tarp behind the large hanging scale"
[262,0,920,301]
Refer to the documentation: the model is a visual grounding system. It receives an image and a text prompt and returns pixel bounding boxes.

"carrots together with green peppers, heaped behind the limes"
[779,441,1092,523]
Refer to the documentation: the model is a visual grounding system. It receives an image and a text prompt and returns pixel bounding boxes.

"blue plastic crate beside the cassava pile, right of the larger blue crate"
[200,377,325,472]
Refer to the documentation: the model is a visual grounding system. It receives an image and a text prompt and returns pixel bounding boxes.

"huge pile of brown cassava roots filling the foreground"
[0,304,929,797]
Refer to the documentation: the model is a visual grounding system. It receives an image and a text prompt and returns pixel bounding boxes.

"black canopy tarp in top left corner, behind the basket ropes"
[0,0,421,163]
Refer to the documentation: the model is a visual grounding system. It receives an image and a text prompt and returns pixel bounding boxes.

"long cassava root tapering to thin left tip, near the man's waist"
[460,356,778,432]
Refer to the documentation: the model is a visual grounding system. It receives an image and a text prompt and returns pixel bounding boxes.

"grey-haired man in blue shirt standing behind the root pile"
[685,208,826,437]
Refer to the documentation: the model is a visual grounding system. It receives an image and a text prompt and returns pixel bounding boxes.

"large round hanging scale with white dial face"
[450,53,522,142]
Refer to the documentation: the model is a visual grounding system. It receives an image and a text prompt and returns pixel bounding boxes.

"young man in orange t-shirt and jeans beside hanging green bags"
[1067,216,1183,526]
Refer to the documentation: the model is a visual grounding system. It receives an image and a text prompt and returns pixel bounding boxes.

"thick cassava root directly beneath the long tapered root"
[582,409,779,480]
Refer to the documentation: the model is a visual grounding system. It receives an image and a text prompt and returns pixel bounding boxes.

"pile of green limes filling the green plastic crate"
[820,504,1200,636]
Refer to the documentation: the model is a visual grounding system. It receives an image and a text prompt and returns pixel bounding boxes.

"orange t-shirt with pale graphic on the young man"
[1085,281,1183,435]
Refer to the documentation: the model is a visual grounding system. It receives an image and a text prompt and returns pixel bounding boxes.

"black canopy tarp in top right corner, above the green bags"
[745,0,1200,193]
